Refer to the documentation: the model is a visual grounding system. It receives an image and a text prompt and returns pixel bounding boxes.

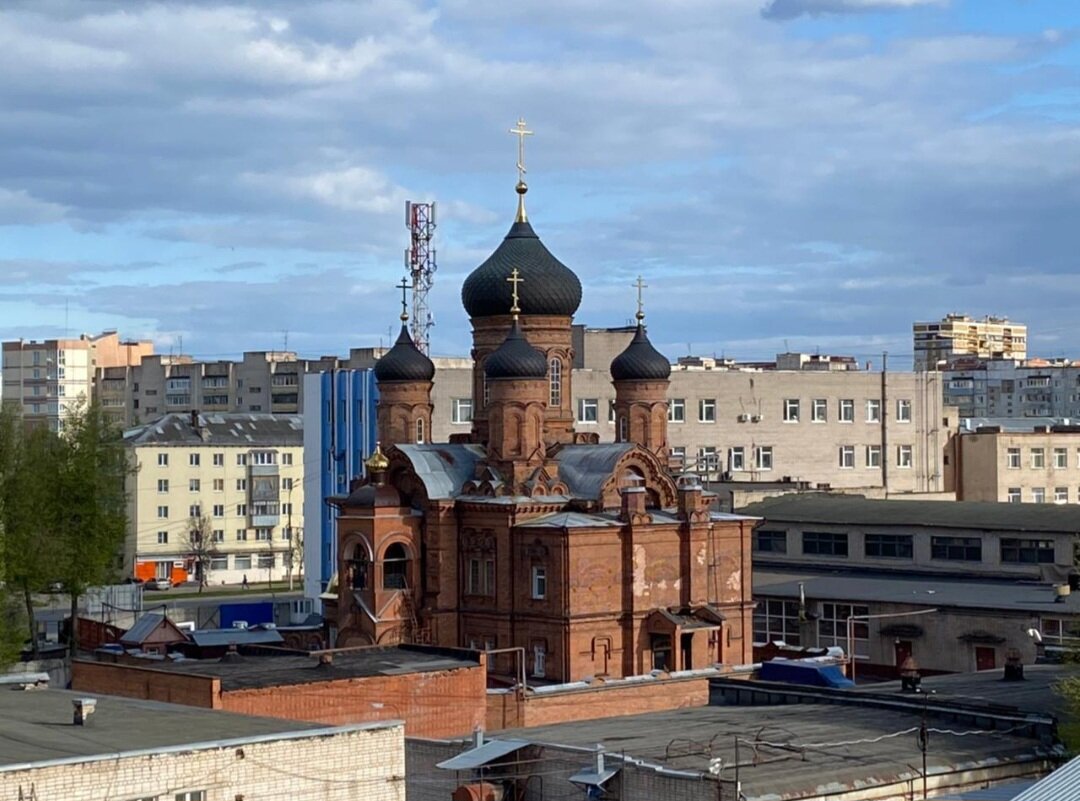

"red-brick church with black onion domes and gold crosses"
[324,126,754,683]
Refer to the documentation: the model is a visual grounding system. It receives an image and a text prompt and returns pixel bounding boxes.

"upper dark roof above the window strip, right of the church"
[739,492,1080,533]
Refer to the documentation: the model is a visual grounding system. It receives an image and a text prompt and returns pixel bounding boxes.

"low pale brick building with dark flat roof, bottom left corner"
[0,689,405,801]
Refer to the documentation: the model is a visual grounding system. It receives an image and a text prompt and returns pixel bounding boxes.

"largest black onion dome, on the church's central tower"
[461,222,581,317]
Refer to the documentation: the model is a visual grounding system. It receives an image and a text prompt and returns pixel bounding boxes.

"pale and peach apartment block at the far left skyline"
[2,331,153,431]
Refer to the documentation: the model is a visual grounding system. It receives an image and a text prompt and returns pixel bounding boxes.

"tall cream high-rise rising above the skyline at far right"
[912,314,1027,370]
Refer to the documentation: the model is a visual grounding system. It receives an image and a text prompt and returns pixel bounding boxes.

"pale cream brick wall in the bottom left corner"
[0,727,405,801]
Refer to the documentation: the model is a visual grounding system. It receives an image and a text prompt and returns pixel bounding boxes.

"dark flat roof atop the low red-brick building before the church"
[123,646,480,692]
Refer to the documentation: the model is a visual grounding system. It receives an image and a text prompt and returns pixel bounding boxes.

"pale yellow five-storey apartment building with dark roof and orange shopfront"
[124,412,305,584]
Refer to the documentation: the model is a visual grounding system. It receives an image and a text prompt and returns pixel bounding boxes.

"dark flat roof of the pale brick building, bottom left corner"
[0,688,399,771]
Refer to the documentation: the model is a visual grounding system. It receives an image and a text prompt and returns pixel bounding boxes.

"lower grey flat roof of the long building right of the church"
[753,568,1080,615]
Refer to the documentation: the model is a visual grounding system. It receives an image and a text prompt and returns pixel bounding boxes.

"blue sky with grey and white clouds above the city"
[0,0,1080,369]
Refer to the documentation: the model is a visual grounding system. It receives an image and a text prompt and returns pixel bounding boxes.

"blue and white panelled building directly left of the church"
[303,369,378,609]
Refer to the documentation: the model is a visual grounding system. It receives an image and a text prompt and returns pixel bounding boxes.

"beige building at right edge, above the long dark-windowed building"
[957,424,1080,503]
